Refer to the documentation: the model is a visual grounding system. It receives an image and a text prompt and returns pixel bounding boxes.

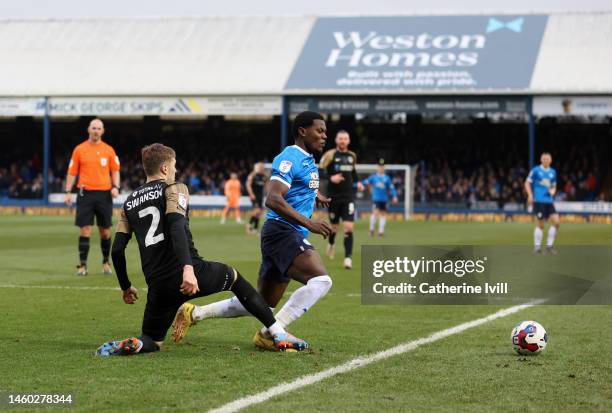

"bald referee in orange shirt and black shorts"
[66,119,120,275]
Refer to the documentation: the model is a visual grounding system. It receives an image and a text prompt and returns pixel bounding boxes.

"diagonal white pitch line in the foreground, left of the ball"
[208,300,545,413]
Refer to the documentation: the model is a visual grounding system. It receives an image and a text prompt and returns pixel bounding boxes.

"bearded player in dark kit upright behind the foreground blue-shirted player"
[319,130,363,269]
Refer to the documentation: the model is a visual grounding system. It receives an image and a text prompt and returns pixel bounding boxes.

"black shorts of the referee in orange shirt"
[74,191,113,228]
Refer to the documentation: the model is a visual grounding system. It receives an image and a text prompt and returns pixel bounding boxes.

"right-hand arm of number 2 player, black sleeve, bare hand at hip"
[165,184,200,295]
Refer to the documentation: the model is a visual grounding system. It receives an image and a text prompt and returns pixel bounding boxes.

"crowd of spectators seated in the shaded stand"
[0,146,600,207]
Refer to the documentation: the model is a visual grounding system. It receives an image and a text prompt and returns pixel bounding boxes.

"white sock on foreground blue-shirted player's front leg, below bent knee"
[276,275,332,327]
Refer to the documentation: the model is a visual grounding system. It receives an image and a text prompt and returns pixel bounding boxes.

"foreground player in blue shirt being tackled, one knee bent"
[182,112,332,350]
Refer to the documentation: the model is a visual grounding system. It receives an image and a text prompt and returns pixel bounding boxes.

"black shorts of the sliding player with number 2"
[142,261,235,341]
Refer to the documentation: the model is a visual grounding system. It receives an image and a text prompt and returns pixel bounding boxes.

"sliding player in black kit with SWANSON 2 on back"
[97,144,308,355]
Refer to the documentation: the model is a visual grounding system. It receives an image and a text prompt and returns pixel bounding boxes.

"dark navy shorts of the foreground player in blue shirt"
[259,219,314,283]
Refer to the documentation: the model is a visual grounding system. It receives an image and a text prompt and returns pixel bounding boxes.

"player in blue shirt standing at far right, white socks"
[525,152,560,254]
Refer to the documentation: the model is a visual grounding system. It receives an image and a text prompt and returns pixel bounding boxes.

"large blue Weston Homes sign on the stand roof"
[286,15,547,90]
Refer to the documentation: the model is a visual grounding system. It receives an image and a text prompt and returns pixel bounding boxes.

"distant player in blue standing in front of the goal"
[361,159,397,237]
